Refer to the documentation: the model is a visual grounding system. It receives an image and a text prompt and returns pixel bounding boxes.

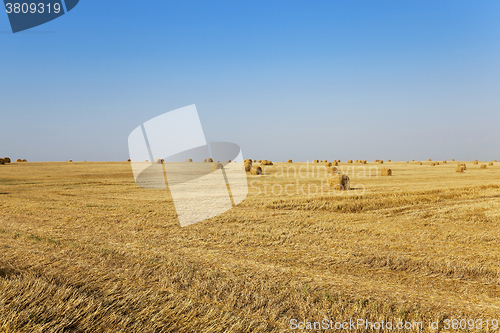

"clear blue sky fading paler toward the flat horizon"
[0,0,500,161]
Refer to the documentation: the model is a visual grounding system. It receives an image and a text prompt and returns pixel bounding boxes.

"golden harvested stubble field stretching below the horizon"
[0,162,500,332]
